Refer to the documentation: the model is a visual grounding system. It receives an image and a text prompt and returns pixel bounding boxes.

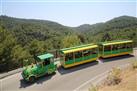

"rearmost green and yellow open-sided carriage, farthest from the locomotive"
[98,40,133,58]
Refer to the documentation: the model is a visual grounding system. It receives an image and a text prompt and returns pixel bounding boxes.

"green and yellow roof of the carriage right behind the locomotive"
[60,44,98,54]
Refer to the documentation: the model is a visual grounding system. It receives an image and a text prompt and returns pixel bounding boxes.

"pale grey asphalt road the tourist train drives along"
[0,50,137,91]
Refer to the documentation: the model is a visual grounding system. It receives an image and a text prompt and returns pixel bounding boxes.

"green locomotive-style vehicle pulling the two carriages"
[22,53,57,82]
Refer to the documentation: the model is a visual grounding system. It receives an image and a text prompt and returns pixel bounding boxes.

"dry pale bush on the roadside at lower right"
[107,68,121,85]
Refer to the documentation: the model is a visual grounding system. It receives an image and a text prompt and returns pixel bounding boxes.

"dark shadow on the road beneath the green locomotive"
[20,73,56,88]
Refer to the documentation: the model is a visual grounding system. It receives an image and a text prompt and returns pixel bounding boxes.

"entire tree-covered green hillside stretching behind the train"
[0,16,137,72]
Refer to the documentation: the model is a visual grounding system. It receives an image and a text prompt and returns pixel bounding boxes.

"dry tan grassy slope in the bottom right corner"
[98,67,137,91]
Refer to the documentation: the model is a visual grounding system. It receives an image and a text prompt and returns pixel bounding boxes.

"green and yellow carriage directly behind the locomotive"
[60,44,99,68]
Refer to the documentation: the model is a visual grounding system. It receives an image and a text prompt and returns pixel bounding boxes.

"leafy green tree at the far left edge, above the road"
[0,28,17,70]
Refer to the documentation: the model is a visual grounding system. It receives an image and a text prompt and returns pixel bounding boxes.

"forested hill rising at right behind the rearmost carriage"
[76,16,137,45]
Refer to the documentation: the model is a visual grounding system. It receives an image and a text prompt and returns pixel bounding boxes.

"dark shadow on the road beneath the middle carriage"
[58,61,98,75]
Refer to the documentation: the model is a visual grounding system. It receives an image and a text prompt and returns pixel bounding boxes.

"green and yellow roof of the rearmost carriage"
[99,40,133,46]
